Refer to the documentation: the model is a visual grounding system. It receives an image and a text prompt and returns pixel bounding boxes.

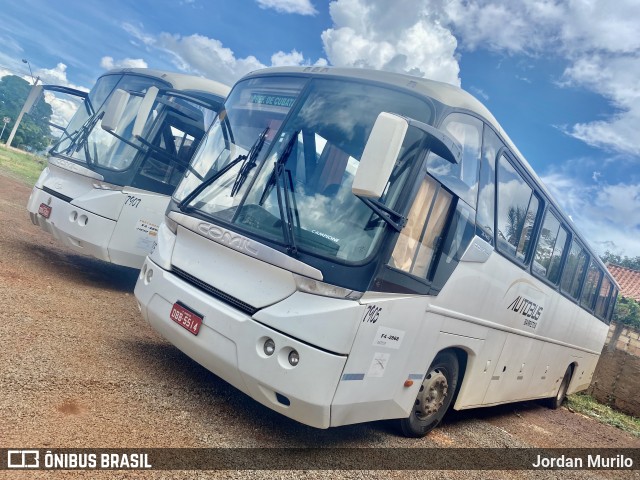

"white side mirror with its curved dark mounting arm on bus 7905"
[351,112,462,198]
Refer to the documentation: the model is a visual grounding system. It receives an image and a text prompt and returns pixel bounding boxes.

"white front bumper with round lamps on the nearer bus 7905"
[135,258,347,428]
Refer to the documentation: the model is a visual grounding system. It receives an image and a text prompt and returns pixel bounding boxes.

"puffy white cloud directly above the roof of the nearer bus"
[322,0,460,85]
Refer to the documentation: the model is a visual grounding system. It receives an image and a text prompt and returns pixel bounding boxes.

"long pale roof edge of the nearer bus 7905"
[243,66,619,288]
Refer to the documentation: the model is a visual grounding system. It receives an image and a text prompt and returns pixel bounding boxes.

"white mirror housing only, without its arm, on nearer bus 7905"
[351,112,409,198]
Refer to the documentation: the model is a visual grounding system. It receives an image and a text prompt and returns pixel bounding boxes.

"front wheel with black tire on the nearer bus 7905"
[400,352,459,438]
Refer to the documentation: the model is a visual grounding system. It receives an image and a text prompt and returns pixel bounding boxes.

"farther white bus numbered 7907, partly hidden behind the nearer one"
[27,69,229,268]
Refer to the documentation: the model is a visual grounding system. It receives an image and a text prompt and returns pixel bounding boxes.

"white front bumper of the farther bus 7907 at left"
[27,187,116,262]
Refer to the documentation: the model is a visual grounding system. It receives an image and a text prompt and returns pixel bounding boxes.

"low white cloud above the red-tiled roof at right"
[542,172,640,257]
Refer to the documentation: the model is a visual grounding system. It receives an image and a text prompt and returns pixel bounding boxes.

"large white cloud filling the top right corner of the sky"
[436,0,640,155]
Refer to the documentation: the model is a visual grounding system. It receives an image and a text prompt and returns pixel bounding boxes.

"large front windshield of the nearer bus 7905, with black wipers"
[175,76,434,263]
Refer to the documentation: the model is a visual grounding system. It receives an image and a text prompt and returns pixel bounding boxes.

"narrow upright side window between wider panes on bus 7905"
[476,126,503,245]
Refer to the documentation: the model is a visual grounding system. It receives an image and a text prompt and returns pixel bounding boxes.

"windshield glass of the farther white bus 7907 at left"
[51,75,166,171]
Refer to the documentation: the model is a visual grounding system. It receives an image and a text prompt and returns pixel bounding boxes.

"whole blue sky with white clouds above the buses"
[0,0,640,257]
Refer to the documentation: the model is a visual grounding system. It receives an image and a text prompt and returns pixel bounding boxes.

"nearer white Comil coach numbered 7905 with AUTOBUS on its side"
[135,67,618,437]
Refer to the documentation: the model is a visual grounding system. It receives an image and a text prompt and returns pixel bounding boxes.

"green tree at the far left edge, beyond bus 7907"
[0,75,53,151]
